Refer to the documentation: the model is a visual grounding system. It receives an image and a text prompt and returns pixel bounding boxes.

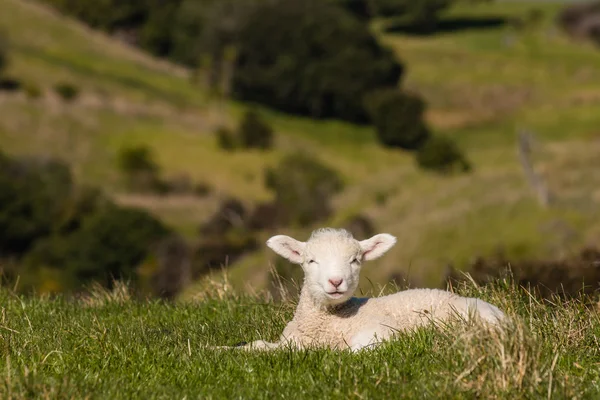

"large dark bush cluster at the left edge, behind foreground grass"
[0,150,169,290]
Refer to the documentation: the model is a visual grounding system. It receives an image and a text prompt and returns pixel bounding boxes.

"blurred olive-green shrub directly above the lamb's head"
[265,153,344,226]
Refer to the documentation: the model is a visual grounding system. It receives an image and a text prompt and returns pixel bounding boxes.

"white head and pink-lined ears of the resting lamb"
[267,228,396,306]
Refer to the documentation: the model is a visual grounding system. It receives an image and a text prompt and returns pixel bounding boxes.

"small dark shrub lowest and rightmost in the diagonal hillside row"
[417,136,471,173]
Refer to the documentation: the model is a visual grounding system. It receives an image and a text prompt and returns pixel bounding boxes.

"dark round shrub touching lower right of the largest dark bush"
[365,89,429,150]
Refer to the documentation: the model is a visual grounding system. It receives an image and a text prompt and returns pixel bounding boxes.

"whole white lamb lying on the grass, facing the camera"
[221,228,505,351]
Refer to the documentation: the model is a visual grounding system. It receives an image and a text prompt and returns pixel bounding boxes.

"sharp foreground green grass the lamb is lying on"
[0,281,600,399]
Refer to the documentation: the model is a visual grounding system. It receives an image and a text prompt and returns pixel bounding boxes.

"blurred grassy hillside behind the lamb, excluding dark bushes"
[0,0,600,295]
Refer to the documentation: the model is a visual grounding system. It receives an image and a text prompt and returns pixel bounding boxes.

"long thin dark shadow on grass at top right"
[386,16,510,36]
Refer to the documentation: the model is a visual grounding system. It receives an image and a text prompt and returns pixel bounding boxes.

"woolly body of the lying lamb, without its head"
[248,289,504,350]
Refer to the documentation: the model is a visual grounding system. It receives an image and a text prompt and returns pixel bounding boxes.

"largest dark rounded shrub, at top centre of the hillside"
[232,0,402,122]
